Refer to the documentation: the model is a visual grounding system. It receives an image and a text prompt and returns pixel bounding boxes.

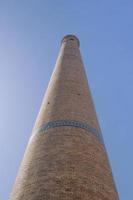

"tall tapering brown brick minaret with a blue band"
[10,35,118,200]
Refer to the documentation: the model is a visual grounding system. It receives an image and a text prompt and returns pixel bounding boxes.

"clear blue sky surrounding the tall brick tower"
[0,0,133,200]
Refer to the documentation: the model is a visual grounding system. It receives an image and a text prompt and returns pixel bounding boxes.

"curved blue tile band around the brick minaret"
[32,119,103,143]
